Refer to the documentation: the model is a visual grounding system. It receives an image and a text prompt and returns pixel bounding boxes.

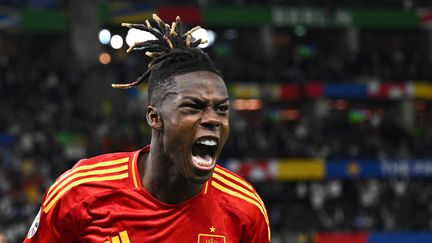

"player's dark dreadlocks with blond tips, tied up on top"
[112,14,222,105]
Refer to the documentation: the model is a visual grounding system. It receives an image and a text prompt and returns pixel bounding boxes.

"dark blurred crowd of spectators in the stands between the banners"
[0,17,432,242]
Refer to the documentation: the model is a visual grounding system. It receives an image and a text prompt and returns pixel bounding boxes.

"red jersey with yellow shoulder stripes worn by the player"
[24,146,270,243]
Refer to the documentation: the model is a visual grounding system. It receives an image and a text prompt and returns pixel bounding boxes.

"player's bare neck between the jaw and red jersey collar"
[138,143,203,204]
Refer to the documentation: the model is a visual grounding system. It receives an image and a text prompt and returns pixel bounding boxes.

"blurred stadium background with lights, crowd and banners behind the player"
[0,0,432,243]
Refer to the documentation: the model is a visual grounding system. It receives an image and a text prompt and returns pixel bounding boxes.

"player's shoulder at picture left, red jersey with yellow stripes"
[42,148,143,213]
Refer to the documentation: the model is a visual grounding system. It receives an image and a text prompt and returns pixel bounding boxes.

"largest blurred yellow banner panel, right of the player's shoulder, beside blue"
[276,159,325,181]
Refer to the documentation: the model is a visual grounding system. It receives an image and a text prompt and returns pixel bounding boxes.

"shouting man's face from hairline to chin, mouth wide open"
[156,71,229,183]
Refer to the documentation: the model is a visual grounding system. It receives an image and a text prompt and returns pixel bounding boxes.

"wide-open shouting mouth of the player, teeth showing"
[192,137,218,170]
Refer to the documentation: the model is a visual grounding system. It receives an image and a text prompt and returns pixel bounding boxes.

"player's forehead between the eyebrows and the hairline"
[174,71,228,98]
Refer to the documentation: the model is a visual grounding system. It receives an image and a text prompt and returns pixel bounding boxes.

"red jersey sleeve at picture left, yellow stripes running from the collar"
[24,153,132,243]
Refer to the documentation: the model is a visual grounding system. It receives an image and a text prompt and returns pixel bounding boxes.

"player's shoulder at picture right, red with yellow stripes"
[210,166,268,221]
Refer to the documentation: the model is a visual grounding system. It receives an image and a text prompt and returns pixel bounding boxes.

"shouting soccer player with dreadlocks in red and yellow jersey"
[24,15,270,243]
